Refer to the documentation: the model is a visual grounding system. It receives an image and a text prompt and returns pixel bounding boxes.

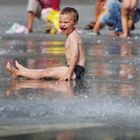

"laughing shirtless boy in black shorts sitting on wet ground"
[6,7,85,81]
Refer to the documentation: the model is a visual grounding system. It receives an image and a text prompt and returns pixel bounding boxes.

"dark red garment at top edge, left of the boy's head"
[39,0,60,10]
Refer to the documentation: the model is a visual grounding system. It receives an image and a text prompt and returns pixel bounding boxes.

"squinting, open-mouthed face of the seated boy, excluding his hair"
[59,13,76,35]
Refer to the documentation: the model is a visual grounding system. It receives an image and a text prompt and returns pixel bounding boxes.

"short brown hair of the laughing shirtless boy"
[60,7,79,22]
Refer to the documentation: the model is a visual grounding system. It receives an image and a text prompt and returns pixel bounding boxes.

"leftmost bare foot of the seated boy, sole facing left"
[6,62,18,79]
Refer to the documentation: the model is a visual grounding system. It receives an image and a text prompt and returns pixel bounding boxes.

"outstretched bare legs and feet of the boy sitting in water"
[6,61,75,79]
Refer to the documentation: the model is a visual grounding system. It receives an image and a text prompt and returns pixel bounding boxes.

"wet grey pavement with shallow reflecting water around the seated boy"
[0,0,140,140]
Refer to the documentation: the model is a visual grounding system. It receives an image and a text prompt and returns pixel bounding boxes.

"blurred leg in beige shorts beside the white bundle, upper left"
[27,0,41,32]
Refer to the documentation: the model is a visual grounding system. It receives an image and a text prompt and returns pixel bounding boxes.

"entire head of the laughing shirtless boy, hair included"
[60,7,79,35]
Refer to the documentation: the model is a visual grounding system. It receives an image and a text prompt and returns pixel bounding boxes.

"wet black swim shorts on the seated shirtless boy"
[74,65,85,79]
